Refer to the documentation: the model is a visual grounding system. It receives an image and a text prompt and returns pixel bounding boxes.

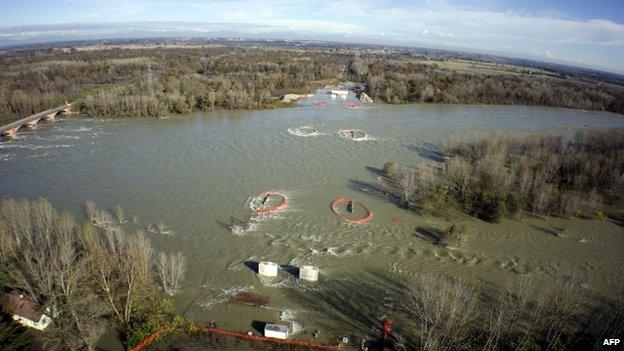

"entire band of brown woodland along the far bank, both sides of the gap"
[0,45,624,123]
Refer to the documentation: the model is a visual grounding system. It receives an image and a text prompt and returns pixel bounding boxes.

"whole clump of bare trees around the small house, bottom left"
[0,199,185,350]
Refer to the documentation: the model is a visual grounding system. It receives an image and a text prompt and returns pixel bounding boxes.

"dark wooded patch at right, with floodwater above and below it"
[384,129,624,221]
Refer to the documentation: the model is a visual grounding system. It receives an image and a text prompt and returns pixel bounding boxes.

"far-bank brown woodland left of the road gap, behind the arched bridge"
[0,47,347,122]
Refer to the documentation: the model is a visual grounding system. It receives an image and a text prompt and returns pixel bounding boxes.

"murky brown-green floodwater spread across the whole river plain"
[0,93,624,349]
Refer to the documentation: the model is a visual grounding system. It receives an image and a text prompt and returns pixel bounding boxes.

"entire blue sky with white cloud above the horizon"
[0,0,624,73]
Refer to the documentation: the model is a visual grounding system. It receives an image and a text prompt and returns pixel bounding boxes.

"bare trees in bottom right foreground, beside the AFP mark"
[394,274,624,351]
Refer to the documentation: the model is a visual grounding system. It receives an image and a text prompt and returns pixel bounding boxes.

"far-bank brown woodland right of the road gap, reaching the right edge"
[349,57,624,113]
